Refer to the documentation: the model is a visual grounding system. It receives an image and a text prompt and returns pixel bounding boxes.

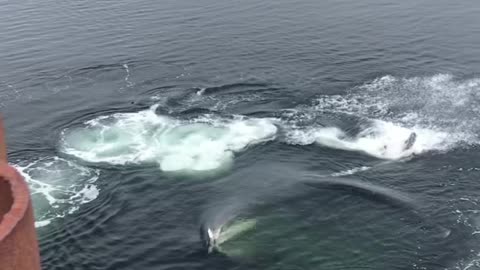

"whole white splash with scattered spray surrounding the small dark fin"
[285,74,480,159]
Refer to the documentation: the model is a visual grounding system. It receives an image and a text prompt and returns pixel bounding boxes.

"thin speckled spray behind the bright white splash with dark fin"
[314,74,480,133]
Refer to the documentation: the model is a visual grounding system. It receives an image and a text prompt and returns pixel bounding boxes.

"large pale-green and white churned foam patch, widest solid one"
[61,107,277,171]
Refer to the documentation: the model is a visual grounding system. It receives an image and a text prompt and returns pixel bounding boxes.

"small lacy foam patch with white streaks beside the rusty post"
[14,157,99,228]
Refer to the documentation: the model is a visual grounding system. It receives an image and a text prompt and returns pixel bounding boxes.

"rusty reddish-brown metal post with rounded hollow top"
[0,115,40,270]
